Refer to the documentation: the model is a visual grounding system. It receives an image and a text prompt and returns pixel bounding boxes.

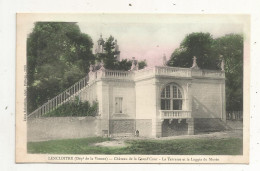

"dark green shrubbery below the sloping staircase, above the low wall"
[44,98,98,117]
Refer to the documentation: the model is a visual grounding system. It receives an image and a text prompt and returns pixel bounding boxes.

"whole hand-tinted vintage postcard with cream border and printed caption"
[16,13,250,164]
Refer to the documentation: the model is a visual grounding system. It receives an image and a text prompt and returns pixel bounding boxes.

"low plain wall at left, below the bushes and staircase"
[27,117,100,142]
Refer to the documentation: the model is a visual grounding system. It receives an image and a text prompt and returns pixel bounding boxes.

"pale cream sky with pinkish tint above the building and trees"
[78,15,243,66]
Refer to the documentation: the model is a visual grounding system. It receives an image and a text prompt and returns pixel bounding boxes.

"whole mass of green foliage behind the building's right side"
[168,33,243,110]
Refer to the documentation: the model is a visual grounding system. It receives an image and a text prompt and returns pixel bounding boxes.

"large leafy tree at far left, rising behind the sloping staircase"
[27,22,94,112]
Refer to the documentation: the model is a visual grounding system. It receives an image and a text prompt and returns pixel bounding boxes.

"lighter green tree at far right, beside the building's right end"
[212,34,243,110]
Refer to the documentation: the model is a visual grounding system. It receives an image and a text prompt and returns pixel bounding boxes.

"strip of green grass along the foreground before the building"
[27,137,243,155]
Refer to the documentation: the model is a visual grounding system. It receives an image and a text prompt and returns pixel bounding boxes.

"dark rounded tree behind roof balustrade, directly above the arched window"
[168,33,217,69]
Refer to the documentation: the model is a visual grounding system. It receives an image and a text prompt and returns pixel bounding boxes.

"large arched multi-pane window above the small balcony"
[161,84,183,110]
